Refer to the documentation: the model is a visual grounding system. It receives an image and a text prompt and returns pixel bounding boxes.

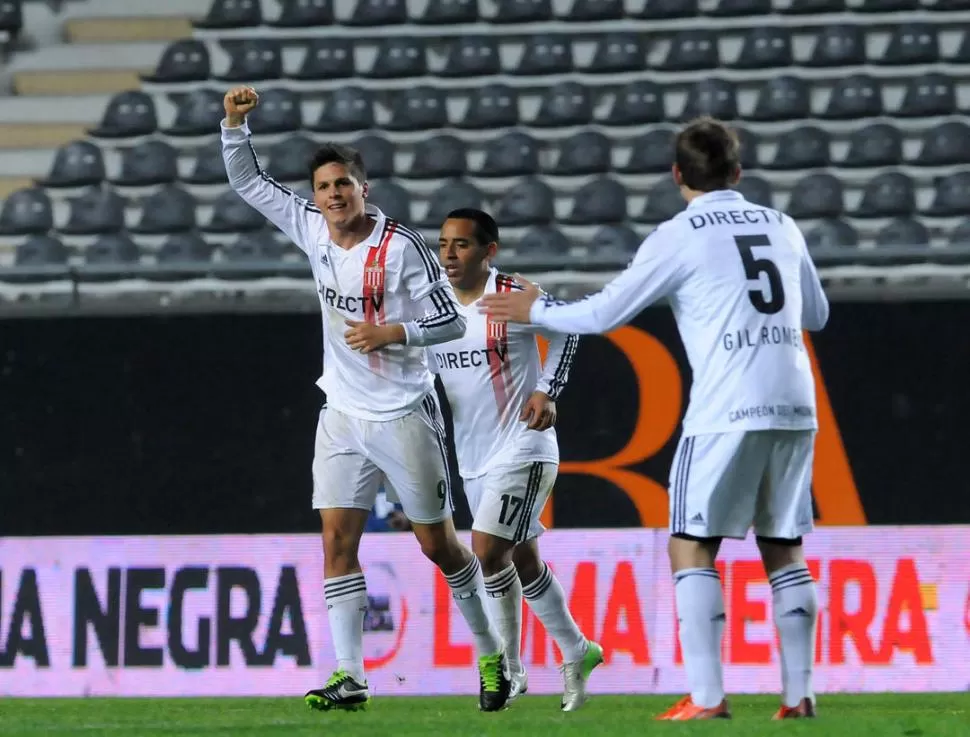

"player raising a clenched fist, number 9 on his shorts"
[222,87,510,711]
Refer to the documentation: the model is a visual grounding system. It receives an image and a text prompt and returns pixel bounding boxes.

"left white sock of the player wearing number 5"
[674,568,724,709]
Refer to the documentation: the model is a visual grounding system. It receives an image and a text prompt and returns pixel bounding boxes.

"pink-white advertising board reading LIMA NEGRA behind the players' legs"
[0,526,970,697]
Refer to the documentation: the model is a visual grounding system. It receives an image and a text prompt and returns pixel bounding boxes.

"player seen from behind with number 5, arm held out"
[482,118,829,720]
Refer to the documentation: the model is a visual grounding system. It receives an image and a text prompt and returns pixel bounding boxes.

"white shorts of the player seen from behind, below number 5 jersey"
[668,430,815,540]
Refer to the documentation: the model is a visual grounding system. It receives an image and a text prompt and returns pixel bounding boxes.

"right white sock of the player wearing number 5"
[768,563,818,706]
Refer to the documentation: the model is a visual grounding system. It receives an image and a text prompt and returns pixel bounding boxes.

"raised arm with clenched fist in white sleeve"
[221,87,313,251]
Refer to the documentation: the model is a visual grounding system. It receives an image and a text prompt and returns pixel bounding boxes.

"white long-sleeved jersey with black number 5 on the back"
[531,190,829,435]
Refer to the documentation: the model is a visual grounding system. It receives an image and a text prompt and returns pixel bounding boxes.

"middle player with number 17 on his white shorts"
[432,209,603,711]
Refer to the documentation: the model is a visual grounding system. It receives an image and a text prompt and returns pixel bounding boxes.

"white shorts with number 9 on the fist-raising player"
[313,393,452,524]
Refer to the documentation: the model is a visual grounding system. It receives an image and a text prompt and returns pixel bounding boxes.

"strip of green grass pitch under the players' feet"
[0,692,970,737]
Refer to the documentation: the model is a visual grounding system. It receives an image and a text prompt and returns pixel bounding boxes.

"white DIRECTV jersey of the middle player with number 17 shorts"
[431,268,579,479]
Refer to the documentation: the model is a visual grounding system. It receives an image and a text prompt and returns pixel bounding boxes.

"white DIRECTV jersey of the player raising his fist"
[222,121,465,420]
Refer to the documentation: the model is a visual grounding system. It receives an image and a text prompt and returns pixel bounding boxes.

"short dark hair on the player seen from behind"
[675,116,741,192]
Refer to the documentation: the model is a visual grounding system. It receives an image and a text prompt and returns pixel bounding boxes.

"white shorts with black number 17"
[464,461,559,543]
